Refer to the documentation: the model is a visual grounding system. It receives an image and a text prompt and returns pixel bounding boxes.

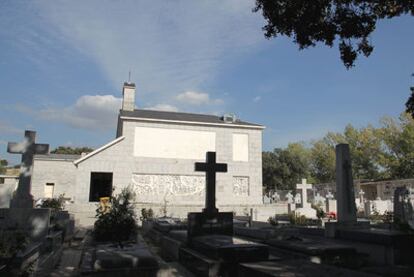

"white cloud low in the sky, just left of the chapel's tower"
[16,95,122,130]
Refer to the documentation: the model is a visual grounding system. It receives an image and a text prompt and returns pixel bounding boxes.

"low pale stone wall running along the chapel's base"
[66,203,288,227]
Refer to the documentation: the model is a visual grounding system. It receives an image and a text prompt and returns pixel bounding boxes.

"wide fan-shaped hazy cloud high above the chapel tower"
[25,0,263,96]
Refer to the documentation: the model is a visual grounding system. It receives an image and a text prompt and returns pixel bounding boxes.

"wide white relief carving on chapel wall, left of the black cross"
[131,174,205,203]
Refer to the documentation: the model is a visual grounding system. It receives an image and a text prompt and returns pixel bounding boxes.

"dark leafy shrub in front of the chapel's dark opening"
[93,187,138,244]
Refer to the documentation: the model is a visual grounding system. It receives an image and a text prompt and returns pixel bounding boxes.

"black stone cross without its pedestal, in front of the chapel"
[195,152,227,214]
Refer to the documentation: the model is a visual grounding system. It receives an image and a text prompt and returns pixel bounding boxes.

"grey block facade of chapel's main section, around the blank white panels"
[75,121,262,206]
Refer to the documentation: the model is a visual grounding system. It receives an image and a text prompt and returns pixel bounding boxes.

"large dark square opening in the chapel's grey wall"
[89,172,112,202]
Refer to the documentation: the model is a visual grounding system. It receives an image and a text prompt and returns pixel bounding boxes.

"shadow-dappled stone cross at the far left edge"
[7,130,49,208]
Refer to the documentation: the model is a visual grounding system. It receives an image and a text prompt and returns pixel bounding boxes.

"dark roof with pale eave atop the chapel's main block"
[119,109,265,129]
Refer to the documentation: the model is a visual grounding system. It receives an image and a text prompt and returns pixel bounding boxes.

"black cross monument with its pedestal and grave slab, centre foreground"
[179,152,269,276]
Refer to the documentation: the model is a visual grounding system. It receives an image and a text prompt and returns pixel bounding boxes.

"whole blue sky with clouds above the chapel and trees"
[0,0,414,163]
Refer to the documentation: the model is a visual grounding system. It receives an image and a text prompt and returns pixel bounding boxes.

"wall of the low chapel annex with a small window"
[32,159,76,199]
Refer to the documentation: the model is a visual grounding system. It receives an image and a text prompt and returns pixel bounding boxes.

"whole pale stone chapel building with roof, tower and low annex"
[32,83,265,222]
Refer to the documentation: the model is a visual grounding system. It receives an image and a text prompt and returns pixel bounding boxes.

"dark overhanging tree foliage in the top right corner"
[253,0,414,69]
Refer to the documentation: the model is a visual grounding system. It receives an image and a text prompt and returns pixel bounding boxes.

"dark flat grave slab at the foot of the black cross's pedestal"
[192,235,269,263]
